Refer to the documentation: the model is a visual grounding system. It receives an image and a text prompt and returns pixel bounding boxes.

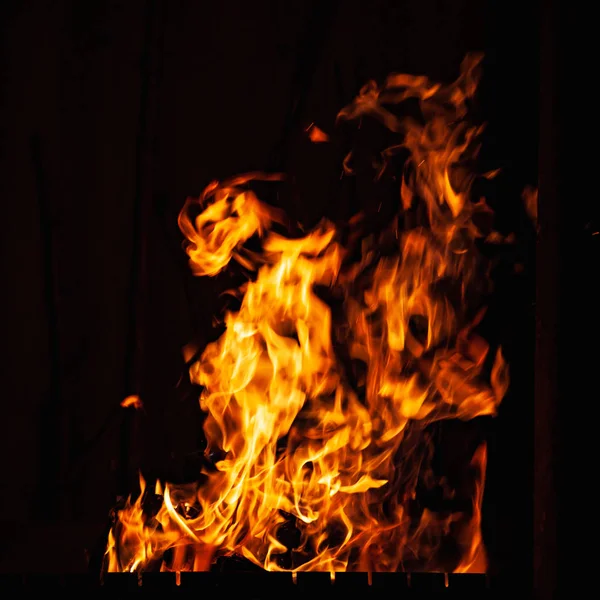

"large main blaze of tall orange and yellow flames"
[107,56,508,572]
